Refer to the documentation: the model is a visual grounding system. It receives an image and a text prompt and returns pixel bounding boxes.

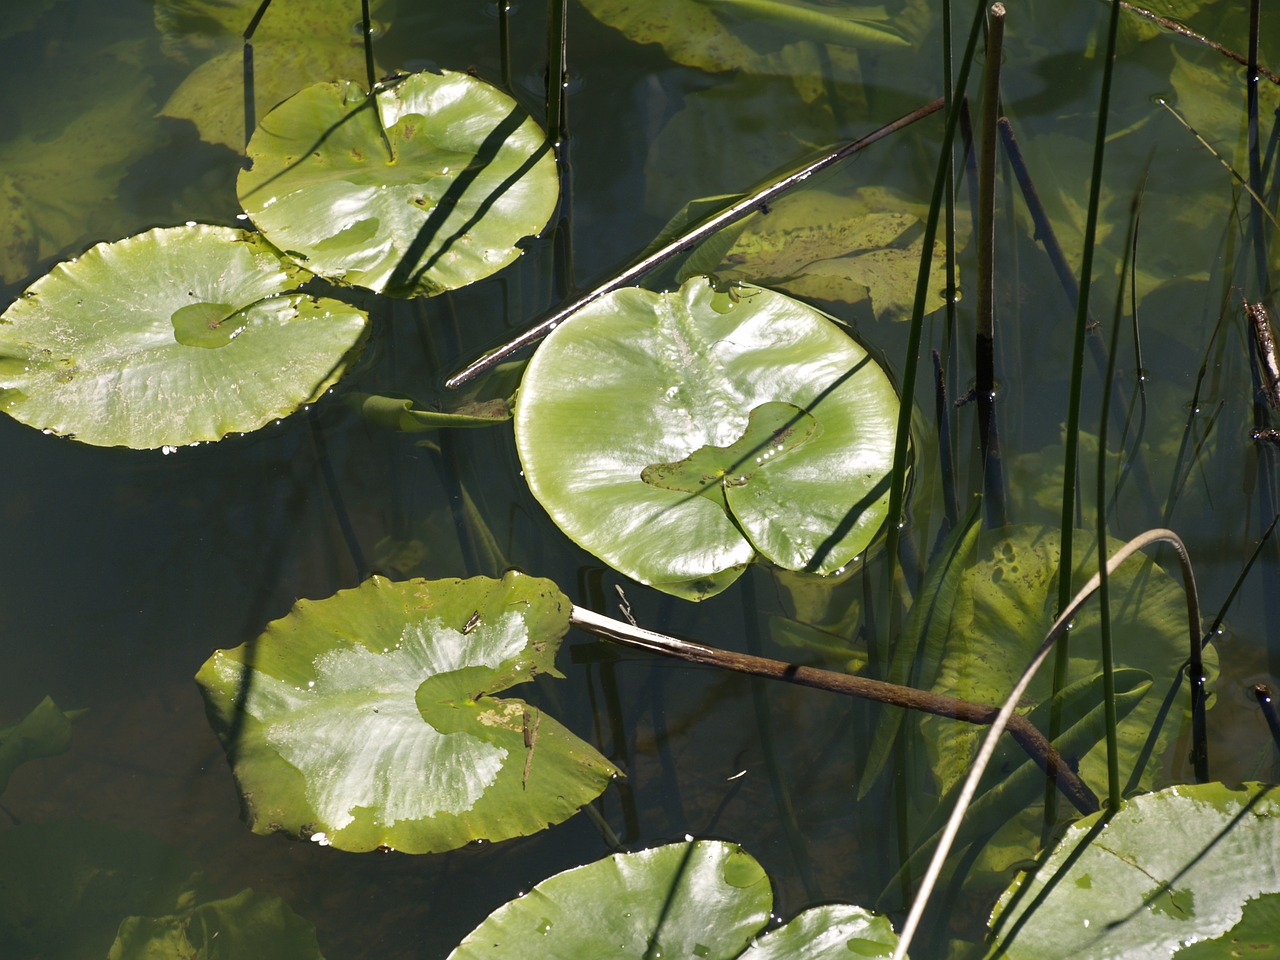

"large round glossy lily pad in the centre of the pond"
[516,278,899,599]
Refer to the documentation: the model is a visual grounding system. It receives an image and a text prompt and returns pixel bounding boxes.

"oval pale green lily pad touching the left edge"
[0,225,369,449]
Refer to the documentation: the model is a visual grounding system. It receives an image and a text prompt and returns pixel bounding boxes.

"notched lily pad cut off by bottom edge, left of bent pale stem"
[449,840,897,960]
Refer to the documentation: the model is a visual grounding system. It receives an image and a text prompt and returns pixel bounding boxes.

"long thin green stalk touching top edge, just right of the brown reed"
[1044,0,1120,823]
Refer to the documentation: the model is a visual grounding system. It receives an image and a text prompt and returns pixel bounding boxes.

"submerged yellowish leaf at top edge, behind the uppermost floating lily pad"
[156,0,388,152]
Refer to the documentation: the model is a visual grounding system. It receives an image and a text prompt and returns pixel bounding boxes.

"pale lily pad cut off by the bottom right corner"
[992,783,1280,960]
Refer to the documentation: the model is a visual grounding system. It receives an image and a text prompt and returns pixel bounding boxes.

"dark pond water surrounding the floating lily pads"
[0,0,1280,960]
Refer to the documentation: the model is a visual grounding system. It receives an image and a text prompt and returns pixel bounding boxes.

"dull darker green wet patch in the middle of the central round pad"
[640,401,820,493]
